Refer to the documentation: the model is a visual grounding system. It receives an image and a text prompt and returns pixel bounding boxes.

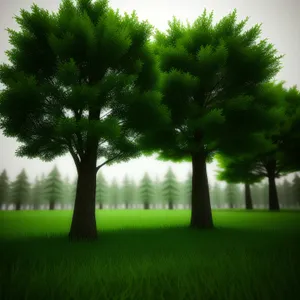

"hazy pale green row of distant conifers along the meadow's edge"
[0,166,300,210]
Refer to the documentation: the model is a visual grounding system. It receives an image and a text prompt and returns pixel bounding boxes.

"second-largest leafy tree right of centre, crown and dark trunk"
[145,11,281,228]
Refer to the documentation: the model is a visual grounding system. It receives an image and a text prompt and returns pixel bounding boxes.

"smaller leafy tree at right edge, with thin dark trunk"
[218,82,300,210]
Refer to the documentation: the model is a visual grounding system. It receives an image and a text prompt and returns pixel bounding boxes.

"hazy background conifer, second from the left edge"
[10,169,30,210]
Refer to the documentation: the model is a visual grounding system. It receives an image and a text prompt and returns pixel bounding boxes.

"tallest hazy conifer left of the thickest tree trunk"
[45,166,63,210]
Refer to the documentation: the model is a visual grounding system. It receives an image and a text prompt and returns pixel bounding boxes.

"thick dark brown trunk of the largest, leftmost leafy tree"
[69,150,97,240]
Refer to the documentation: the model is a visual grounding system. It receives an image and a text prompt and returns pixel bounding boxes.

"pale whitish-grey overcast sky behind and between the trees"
[0,0,300,183]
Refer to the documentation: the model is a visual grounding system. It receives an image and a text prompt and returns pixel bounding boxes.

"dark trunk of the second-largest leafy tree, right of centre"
[190,151,214,228]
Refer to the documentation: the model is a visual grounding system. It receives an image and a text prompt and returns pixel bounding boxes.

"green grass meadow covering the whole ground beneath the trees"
[0,210,300,300]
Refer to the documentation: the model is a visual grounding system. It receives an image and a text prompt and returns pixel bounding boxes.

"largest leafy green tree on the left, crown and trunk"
[0,0,168,239]
